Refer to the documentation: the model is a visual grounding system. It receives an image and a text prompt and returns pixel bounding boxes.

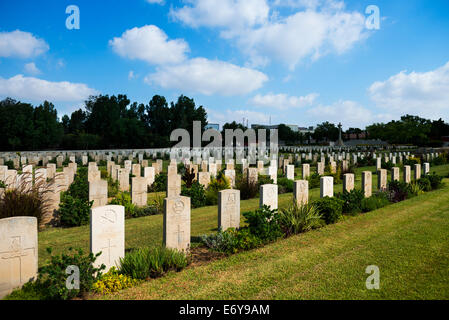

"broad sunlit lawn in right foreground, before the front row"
[101,179,449,299]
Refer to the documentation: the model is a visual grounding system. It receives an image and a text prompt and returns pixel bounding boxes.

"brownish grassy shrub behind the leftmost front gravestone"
[0,174,49,224]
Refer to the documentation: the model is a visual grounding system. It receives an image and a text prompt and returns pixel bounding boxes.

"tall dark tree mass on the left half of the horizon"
[0,95,207,151]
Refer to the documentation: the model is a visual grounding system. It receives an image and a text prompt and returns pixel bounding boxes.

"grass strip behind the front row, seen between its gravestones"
[39,165,449,266]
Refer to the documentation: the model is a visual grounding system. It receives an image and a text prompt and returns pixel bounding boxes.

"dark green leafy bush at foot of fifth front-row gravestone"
[243,205,282,242]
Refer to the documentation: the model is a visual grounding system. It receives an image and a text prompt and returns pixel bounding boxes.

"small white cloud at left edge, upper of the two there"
[0,30,50,58]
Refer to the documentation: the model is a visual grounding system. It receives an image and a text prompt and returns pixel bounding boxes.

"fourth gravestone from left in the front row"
[218,189,240,231]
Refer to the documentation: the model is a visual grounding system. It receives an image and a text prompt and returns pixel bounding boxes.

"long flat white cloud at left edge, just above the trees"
[0,74,98,102]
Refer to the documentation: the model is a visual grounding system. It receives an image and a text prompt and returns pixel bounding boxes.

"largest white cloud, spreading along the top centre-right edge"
[171,0,368,70]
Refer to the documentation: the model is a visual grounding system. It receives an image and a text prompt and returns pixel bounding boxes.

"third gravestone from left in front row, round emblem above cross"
[163,196,190,251]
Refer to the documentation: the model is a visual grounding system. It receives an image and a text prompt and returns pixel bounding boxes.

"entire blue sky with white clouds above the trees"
[0,0,449,128]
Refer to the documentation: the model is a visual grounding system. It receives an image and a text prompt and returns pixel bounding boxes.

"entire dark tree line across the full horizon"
[0,95,449,151]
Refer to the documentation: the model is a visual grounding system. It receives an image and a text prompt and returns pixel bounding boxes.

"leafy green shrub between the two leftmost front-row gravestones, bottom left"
[35,248,105,300]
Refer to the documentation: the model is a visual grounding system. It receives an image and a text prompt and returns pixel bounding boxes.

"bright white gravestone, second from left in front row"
[90,206,125,272]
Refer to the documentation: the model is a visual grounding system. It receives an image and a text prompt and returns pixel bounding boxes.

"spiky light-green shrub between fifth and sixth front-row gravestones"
[279,201,321,236]
